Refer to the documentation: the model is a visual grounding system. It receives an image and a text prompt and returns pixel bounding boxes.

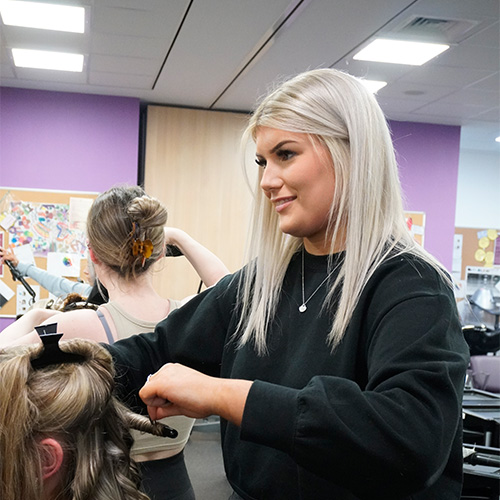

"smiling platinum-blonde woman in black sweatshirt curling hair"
[105,69,468,500]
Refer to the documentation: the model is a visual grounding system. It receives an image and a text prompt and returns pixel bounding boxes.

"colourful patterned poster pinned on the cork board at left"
[9,201,86,257]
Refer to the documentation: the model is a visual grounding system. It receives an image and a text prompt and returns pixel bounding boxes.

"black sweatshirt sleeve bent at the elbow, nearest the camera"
[241,262,468,498]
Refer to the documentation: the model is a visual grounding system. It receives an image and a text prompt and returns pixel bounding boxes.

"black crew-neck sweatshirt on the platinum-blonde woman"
[109,253,468,500]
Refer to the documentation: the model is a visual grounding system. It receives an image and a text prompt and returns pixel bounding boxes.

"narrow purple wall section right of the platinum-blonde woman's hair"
[390,121,460,272]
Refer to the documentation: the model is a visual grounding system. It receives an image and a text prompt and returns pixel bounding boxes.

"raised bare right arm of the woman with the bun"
[165,227,229,287]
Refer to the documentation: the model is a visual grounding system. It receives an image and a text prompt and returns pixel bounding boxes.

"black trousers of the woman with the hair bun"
[138,451,195,500]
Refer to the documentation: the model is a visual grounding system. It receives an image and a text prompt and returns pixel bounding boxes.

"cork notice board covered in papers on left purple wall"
[0,187,98,317]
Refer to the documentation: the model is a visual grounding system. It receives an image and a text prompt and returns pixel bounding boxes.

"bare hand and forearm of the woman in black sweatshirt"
[139,363,252,425]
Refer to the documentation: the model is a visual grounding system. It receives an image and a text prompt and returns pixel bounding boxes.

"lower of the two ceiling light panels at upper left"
[12,49,83,72]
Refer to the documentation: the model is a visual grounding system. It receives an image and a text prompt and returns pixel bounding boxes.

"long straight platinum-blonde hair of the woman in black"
[238,69,451,355]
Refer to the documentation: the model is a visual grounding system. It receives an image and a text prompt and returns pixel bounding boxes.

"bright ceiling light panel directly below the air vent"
[353,38,450,66]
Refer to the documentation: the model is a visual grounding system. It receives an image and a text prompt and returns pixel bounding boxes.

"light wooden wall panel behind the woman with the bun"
[145,106,257,299]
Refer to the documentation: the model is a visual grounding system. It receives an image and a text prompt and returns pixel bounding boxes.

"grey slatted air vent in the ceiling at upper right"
[391,16,478,43]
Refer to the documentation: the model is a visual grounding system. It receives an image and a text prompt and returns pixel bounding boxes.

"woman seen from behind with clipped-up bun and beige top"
[0,186,228,500]
